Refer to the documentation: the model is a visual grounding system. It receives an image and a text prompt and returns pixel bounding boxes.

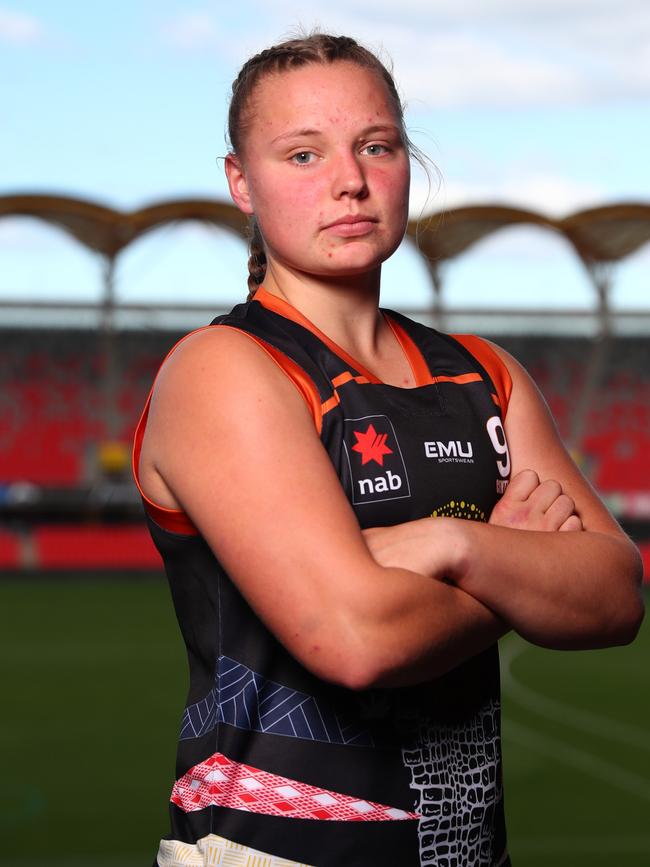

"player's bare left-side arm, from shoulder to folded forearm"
[140,328,507,688]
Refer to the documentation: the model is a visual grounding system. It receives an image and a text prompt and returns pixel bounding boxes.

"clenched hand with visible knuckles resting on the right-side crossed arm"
[488,470,584,532]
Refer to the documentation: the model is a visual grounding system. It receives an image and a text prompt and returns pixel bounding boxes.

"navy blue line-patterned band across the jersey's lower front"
[180,656,375,747]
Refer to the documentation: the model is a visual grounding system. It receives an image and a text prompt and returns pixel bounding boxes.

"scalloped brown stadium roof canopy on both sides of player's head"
[0,195,650,268]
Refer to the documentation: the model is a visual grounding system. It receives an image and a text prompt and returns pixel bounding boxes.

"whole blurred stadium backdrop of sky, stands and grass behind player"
[0,0,650,867]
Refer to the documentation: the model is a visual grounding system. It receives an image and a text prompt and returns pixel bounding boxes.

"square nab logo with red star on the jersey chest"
[343,415,411,505]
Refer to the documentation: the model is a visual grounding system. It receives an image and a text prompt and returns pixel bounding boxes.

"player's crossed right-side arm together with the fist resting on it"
[364,347,643,649]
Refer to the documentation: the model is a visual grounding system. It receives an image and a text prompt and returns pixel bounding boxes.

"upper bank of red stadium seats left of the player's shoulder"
[0,329,170,486]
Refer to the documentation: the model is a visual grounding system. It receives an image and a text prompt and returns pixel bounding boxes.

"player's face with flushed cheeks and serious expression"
[226,61,410,277]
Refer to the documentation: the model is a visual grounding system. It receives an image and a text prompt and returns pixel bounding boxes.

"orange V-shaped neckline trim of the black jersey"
[253,286,435,390]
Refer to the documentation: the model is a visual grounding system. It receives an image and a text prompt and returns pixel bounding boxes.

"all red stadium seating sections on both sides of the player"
[0,328,650,572]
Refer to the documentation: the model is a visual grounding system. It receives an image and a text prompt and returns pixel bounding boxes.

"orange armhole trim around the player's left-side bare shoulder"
[131,325,323,536]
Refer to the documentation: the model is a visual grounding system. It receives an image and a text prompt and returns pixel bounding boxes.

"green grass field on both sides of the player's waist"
[0,576,650,867]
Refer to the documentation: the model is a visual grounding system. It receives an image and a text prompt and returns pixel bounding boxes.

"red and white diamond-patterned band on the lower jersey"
[171,753,420,822]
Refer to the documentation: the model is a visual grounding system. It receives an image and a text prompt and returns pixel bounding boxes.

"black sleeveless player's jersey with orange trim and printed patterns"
[134,289,511,867]
